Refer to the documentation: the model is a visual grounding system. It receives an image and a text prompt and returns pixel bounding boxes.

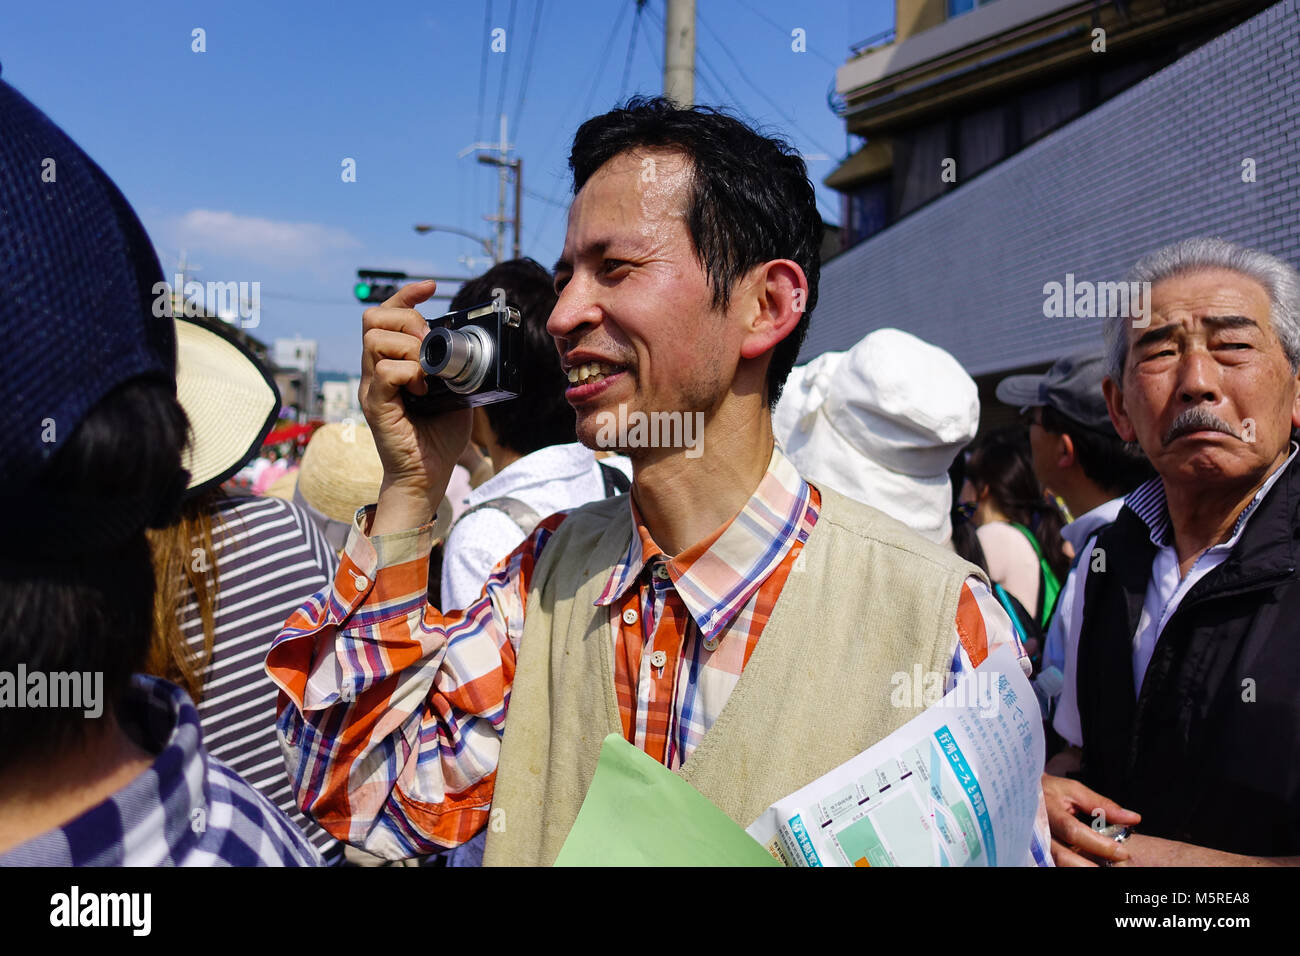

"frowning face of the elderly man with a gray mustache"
[1106,269,1300,484]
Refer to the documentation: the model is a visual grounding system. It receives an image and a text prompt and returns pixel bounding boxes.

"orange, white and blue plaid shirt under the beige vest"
[267,449,1049,862]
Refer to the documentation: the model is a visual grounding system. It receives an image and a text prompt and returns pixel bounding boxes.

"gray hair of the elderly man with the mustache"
[1104,237,1300,385]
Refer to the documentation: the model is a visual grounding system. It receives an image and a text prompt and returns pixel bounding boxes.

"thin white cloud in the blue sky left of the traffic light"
[177,209,361,267]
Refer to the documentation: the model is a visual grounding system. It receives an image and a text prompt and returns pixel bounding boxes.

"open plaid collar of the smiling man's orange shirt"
[595,446,809,640]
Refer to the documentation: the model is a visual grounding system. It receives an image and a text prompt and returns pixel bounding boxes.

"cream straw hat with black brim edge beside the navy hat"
[176,316,280,497]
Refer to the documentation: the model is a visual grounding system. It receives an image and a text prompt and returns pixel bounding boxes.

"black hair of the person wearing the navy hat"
[0,378,189,770]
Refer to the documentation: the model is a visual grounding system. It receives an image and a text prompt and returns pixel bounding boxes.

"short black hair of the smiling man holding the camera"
[569,96,823,408]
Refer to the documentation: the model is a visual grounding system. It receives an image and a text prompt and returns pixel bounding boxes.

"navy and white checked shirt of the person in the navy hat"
[0,674,320,866]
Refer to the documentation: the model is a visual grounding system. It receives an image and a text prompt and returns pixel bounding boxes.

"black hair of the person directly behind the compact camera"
[451,259,577,455]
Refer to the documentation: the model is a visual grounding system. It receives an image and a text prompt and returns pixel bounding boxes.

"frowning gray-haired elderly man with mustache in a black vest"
[1043,238,1300,866]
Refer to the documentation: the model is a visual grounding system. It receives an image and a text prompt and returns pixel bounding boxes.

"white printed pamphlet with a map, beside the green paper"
[749,648,1044,866]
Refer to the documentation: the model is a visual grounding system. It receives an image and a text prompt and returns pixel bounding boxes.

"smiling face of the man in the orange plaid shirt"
[546,150,742,447]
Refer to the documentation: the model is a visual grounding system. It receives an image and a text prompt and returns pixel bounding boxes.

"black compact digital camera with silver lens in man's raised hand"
[403,299,523,416]
